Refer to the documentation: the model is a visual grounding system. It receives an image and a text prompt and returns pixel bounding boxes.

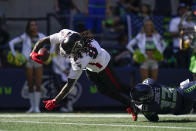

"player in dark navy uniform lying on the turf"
[130,78,196,122]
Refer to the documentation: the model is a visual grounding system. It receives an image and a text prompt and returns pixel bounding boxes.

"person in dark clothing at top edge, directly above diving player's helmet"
[55,0,81,28]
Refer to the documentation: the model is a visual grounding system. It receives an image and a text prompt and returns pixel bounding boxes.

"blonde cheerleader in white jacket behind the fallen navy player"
[127,20,166,80]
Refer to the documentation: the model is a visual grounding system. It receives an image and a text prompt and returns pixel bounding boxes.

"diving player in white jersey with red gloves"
[30,29,136,118]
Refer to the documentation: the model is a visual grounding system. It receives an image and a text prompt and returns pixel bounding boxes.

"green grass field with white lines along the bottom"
[0,113,196,131]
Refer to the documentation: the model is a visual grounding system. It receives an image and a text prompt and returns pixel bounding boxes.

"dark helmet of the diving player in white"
[60,33,84,55]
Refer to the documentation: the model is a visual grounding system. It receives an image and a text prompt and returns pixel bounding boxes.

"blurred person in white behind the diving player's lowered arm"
[52,46,82,112]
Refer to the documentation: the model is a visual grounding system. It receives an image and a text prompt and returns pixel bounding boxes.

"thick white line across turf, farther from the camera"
[0,113,196,118]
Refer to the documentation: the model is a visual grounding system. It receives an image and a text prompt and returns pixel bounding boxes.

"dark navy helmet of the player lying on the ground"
[130,84,154,104]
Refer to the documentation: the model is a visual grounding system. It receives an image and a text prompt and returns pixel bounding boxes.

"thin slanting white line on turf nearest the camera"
[0,120,196,130]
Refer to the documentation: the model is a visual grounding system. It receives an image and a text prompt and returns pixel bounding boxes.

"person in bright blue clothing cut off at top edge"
[85,0,110,33]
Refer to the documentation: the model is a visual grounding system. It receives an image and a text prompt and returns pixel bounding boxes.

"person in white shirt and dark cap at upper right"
[169,3,195,68]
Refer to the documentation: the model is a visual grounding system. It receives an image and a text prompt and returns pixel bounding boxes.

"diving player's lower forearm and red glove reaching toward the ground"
[43,79,76,110]
